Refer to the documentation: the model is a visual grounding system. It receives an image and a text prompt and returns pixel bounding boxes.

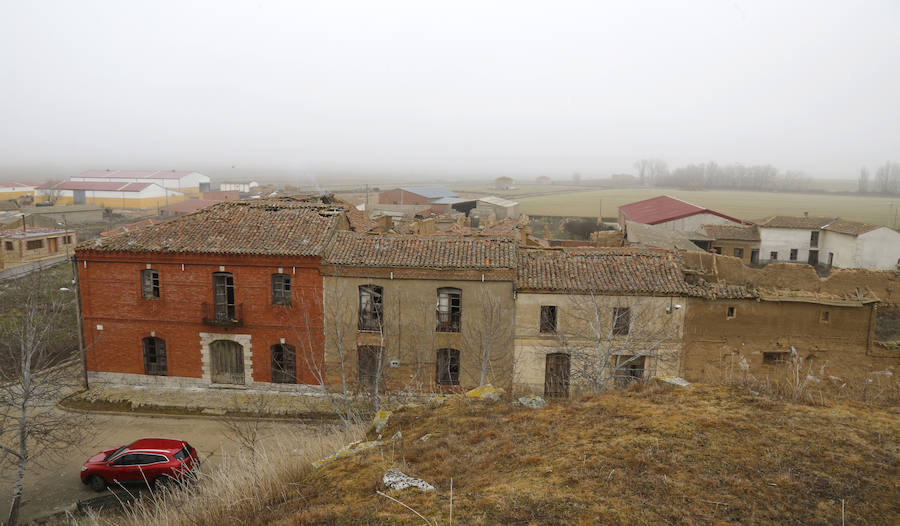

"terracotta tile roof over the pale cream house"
[517,248,697,295]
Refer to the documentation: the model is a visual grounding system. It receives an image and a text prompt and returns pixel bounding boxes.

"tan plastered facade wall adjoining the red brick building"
[324,269,515,391]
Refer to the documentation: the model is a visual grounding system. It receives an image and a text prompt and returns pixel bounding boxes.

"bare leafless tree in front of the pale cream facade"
[557,294,682,393]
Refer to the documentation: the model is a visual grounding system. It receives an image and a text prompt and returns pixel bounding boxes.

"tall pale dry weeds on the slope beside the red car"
[81,426,364,526]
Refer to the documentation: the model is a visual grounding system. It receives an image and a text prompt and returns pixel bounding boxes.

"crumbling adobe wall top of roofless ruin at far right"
[682,252,900,304]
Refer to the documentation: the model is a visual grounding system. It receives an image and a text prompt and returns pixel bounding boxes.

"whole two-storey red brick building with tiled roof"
[76,198,350,388]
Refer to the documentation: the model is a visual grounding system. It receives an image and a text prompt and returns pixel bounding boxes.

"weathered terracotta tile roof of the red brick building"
[78,198,344,256]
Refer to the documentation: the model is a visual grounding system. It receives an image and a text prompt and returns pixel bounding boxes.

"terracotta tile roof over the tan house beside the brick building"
[323,231,516,269]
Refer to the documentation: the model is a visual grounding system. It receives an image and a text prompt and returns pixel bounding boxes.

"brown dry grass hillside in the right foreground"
[279,385,900,525]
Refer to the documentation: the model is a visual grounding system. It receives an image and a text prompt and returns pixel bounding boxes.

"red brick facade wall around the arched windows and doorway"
[78,250,323,385]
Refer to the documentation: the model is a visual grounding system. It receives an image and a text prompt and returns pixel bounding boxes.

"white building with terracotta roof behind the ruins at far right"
[757,216,900,269]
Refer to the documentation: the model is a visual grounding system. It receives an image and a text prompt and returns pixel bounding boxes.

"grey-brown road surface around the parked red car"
[0,414,313,523]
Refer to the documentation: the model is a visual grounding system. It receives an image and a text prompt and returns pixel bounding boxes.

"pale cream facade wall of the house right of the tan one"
[514,292,686,393]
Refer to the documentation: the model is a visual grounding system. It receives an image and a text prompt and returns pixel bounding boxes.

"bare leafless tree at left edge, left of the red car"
[0,270,86,525]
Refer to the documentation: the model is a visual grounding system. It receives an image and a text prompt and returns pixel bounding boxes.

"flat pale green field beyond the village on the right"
[518,188,900,227]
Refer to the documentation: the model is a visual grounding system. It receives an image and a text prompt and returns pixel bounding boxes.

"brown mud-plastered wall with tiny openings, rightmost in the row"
[683,298,888,381]
